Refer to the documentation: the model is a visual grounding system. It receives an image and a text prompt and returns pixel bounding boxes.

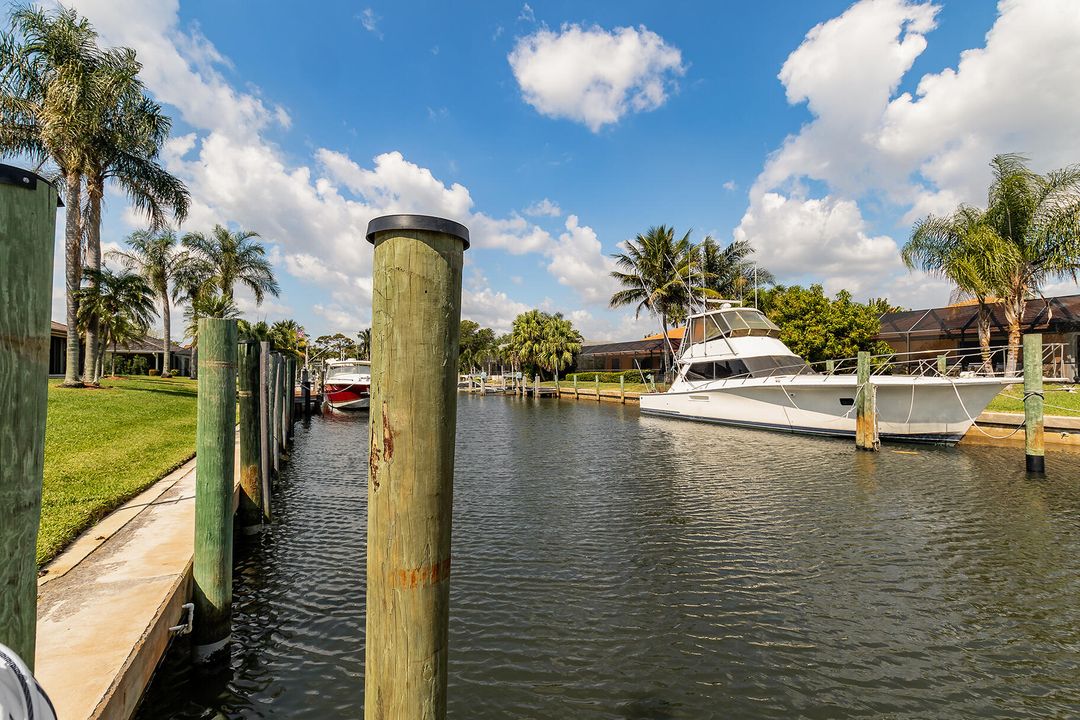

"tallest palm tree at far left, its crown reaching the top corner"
[0,6,135,388]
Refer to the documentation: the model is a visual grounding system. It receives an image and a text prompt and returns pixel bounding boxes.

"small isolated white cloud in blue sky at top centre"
[508,24,685,132]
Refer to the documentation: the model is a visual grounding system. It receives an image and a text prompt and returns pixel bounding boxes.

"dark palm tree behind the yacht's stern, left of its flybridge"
[609,226,696,360]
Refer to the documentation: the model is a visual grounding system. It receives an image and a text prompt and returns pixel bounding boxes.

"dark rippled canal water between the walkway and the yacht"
[139,395,1080,720]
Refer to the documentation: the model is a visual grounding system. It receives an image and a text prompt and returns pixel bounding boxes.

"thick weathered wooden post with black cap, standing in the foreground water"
[364,215,469,720]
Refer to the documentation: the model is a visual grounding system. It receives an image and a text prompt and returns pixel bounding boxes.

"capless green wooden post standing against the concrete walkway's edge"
[192,317,237,660]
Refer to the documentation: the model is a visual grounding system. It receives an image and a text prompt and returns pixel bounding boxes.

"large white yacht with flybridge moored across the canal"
[640,302,1016,445]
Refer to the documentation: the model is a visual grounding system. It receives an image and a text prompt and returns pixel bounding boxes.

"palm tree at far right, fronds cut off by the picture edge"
[985,153,1080,375]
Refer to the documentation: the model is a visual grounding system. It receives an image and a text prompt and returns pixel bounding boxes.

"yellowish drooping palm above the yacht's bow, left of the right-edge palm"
[901,205,1020,370]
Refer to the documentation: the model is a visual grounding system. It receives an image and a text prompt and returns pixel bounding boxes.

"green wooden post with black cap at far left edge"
[0,165,58,669]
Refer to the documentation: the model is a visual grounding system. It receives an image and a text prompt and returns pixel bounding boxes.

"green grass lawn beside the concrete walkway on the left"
[38,376,195,563]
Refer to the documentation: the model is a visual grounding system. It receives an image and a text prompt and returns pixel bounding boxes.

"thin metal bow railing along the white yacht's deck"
[695,342,1077,382]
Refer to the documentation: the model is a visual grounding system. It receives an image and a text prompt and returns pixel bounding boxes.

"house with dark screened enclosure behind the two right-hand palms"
[877,295,1080,380]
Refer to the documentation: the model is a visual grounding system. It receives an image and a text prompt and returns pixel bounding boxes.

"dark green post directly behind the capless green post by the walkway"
[237,340,262,530]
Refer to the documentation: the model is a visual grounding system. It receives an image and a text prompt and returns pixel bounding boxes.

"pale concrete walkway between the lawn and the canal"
[36,451,239,720]
